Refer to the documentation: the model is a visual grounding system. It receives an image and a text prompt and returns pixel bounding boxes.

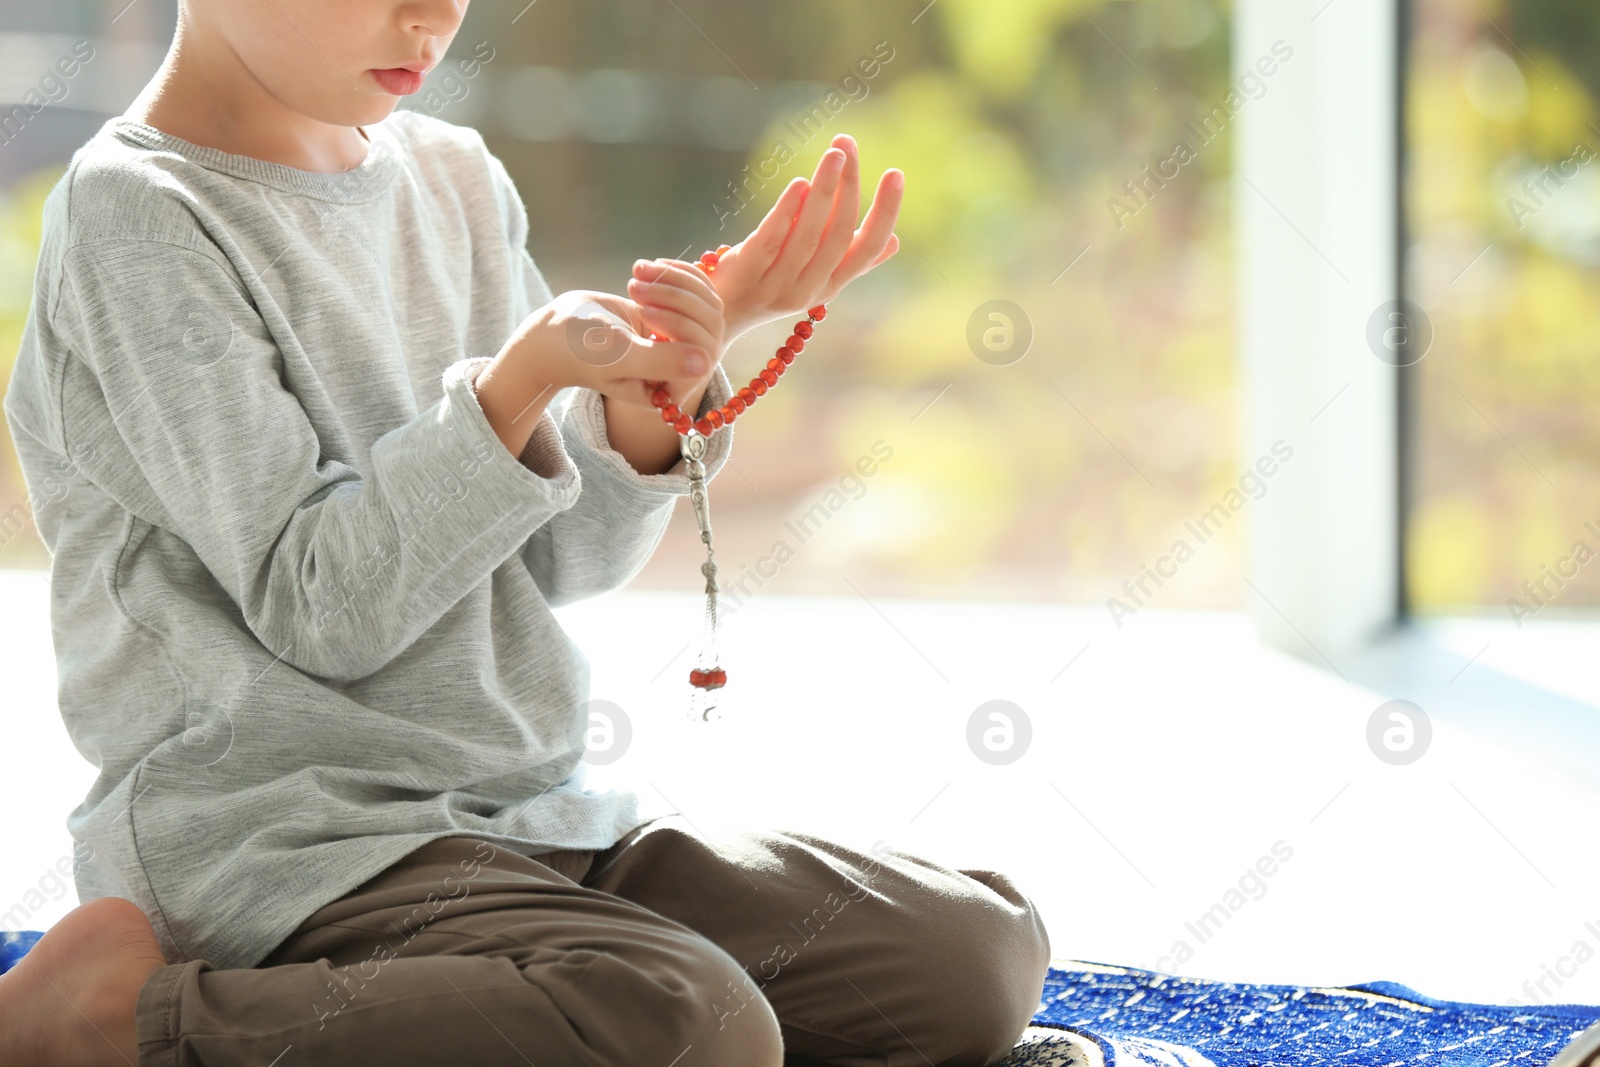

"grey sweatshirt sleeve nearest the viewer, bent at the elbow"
[51,238,592,681]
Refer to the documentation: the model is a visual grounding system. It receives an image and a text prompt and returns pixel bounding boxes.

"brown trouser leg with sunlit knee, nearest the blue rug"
[582,816,1050,1067]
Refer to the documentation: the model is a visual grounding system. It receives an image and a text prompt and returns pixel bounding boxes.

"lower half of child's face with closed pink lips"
[194,0,470,126]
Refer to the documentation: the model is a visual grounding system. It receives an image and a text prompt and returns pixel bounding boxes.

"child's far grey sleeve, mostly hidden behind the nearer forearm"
[522,363,734,608]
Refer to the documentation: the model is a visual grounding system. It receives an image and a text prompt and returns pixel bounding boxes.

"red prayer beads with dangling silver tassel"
[650,245,827,721]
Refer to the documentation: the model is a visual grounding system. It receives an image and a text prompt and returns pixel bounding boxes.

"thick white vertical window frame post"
[1230,0,1410,672]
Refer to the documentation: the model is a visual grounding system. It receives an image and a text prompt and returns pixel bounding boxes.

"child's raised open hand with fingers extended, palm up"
[634,134,906,342]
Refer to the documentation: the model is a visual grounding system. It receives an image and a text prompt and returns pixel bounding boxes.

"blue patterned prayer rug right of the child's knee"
[997,961,1600,1067]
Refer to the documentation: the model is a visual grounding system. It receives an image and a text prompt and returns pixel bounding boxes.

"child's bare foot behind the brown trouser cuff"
[0,896,166,1067]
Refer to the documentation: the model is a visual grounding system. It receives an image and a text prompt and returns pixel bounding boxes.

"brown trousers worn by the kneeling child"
[136,816,1050,1067]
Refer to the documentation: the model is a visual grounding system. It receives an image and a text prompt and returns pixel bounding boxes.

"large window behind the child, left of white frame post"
[0,0,1241,609]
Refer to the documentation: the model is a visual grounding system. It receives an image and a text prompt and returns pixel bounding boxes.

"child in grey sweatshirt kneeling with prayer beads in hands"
[0,0,1050,1067]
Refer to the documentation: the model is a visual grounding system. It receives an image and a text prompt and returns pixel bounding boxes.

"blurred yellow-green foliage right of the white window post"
[1406,0,1600,617]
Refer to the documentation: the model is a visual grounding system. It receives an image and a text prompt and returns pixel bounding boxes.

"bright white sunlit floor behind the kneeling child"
[0,571,1600,1003]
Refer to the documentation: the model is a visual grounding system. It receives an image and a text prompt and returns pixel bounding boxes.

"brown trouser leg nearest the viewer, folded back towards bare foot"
[136,837,782,1067]
